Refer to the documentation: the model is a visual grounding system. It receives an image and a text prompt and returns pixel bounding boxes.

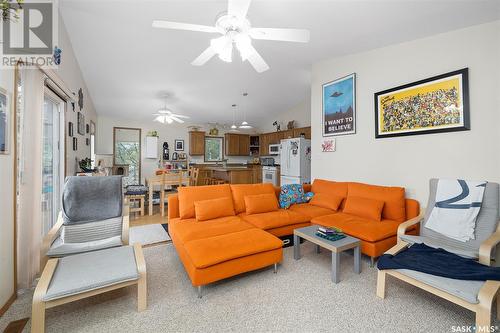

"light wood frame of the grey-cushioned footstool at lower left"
[31,243,147,333]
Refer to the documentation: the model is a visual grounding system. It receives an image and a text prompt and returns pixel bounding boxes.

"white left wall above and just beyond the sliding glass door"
[55,16,97,176]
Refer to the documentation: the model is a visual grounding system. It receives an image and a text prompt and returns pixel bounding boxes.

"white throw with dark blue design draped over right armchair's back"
[425,179,486,242]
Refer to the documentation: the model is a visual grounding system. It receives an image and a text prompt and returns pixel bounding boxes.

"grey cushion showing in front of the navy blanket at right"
[396,269,485,304]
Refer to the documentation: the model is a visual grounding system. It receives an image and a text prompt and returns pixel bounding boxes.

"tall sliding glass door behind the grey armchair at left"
[41,90,65,235]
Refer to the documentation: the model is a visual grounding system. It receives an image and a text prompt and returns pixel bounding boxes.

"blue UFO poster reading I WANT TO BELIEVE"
[321,73,356,136]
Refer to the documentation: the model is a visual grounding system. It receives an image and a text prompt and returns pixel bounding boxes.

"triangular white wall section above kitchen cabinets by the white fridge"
[257,98,311,133]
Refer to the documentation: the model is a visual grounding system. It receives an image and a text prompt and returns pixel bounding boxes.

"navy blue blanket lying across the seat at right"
[377,244,500,281]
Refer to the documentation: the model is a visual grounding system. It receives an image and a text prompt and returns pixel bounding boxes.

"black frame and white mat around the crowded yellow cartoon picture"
[374,68,471,139]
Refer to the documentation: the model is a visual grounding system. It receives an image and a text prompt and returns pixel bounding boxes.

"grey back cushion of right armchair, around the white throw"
[420,179,500,254]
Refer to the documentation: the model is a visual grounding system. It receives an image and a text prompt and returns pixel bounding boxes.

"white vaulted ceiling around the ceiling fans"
[60,0,500,124]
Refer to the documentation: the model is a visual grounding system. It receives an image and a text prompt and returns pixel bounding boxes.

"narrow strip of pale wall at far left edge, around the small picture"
[0,69,15,308]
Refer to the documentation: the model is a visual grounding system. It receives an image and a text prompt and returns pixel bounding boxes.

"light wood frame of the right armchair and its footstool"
[377,208,500,332]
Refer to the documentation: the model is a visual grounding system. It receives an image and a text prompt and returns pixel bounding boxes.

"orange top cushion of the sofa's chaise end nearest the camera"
[184,229,283,268]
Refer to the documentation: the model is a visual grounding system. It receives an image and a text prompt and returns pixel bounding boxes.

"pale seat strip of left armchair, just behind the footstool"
[47,236,123,258]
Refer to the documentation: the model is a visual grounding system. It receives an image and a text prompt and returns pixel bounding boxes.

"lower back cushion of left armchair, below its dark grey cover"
[61,216,122,243]
